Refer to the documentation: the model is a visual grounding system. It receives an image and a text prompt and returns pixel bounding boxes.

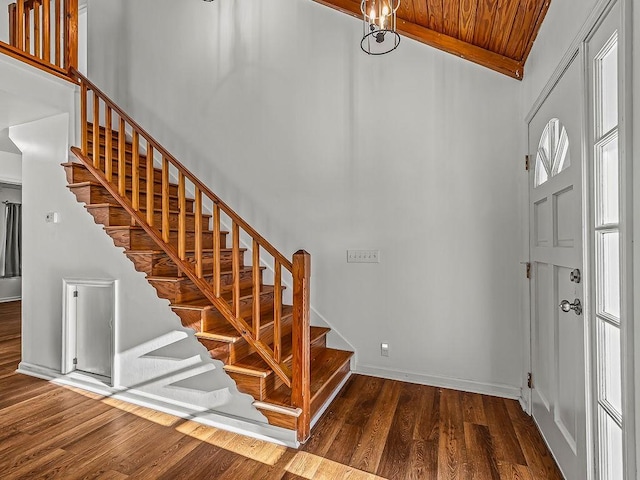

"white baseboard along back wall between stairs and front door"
[354,363,522,400]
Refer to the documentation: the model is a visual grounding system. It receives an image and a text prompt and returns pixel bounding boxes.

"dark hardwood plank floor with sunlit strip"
[0,302,562,480]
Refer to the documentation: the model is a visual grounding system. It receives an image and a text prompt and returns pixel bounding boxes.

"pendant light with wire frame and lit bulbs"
[360,0,400,55]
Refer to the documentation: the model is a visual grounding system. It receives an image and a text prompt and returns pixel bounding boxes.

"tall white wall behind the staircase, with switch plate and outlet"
[89,0,523,395]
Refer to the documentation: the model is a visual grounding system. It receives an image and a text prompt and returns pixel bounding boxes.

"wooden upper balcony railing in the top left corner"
[0,0,78,81]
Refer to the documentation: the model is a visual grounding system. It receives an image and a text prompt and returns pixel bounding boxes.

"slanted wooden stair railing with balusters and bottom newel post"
[71,69,311,440]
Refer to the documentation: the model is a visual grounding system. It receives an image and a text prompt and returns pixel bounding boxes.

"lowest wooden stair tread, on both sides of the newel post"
[264,348,353,408]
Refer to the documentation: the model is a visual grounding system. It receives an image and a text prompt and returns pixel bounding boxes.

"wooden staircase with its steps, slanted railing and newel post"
[63,71,352,442]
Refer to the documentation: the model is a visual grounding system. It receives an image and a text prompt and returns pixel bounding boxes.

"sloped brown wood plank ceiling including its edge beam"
[315,0,551,80]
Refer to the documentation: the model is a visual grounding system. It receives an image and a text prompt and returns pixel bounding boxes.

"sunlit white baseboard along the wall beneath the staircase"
[17,362,300,448]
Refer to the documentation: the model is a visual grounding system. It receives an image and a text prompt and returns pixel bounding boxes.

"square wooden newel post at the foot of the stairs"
[291,250,311,442]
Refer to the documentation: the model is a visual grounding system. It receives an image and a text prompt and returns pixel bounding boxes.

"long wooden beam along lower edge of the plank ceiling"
[314,0,524,80]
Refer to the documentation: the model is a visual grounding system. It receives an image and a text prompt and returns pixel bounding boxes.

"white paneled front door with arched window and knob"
[529,56,587,480]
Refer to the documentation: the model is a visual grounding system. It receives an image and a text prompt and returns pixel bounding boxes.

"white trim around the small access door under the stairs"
[60,278,119,387]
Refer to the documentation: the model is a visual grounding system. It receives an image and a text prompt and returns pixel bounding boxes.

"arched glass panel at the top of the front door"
[534,118,571,187]
